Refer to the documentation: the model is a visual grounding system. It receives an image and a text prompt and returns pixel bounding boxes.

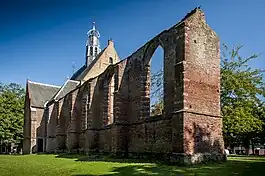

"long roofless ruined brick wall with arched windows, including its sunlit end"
[40,6,223,162]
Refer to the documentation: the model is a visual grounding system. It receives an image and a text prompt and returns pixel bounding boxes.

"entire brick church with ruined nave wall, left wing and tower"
[23,8,225,163]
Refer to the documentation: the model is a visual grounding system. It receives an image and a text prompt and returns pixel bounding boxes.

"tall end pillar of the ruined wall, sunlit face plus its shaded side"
[167,9,225,164]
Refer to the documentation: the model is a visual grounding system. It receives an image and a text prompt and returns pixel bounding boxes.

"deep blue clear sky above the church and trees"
[0,0,265,86]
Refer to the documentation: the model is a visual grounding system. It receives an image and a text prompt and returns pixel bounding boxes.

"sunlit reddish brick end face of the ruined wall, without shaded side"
[183,8,224,154]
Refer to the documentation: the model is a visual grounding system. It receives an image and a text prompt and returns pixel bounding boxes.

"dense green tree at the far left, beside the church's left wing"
[0,83,25,148]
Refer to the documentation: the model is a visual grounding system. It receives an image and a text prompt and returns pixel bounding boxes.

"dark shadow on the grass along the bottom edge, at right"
[71,161,265,176]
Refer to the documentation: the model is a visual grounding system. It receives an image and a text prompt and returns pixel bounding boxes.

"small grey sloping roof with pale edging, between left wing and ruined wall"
[51,79,80,101]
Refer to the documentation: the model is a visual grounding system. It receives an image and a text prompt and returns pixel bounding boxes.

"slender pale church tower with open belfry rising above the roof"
[86,22,101,67]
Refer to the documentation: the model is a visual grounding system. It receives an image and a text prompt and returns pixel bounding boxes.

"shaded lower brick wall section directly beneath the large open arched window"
[127,116,171,153]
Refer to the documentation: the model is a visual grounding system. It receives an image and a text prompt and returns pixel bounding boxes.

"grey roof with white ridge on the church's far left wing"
[27,80,60,108]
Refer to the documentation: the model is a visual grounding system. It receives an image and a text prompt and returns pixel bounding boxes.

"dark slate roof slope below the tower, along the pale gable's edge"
[71,48,106,80]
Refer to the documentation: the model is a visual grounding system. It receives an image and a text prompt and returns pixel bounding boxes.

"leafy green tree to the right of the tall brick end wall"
[221,45,265,149]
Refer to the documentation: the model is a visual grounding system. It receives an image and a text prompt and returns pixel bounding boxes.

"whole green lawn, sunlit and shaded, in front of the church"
[0,155,265,176]
